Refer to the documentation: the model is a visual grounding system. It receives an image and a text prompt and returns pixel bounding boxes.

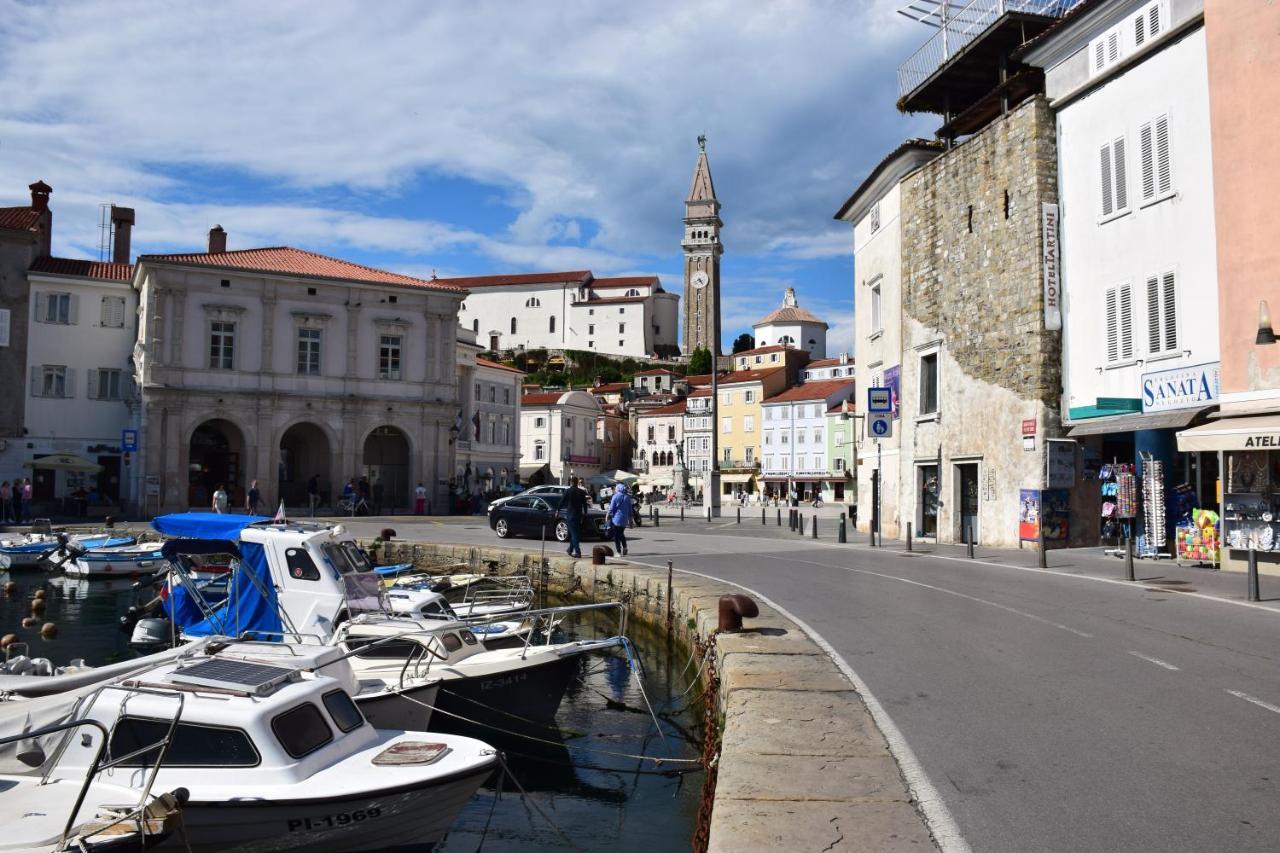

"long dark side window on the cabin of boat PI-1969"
[109,716,258,767]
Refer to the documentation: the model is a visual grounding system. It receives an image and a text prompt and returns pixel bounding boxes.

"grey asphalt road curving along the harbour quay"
[352,511,1280,853]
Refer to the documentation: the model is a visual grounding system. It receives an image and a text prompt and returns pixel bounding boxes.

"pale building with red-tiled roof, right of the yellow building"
[760,379,854,501]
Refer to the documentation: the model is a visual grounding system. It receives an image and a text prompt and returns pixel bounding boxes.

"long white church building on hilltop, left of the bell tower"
[445,270,680,357]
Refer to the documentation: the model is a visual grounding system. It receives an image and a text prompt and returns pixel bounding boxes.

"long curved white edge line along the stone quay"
[631,561,972,853]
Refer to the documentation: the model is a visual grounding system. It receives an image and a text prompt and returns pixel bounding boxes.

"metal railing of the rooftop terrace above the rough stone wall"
[897,0,1080,97]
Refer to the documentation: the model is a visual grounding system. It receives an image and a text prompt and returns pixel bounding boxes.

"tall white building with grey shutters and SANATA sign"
[1028,0,1220,522]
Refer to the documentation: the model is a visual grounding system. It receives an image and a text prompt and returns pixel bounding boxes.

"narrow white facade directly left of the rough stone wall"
[836,140,942,537]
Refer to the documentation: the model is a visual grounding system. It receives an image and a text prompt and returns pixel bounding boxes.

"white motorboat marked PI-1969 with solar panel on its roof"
[16,643,498,853]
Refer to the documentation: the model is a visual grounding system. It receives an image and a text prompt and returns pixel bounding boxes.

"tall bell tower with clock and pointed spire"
[680,136,724,356]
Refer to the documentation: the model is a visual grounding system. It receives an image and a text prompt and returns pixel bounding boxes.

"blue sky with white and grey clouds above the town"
[0,0,936,353]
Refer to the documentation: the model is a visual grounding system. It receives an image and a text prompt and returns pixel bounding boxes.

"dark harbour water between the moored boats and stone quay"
[0,571,703,853]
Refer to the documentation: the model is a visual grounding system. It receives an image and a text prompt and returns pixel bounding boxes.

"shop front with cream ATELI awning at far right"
[1178,415,1280,574]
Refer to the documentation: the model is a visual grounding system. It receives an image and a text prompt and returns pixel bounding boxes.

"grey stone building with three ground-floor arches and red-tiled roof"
[133,227,466,511]
